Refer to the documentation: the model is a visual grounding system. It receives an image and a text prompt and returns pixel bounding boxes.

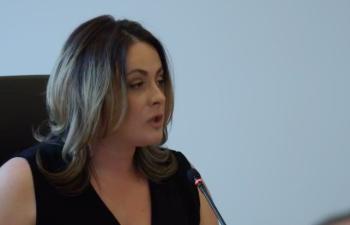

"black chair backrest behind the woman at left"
[0,75,49,165]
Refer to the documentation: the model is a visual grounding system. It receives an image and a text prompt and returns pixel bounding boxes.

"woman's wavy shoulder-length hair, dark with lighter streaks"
[36,15,177,192]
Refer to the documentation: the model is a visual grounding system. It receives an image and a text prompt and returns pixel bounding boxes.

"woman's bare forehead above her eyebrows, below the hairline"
[126,42,162,71]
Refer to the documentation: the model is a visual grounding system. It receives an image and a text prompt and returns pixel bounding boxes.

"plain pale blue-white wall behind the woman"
[0,0,350,225]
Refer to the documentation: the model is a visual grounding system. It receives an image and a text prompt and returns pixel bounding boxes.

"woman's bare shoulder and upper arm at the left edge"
[0,157,36,225]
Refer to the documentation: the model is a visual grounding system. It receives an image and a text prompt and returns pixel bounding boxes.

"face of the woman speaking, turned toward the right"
[113,42,166,147]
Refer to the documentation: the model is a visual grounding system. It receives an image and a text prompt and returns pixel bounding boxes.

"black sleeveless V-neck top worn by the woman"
[18,143,200,225]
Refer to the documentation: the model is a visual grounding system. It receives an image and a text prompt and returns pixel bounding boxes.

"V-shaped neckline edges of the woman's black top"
[88,179,155,225]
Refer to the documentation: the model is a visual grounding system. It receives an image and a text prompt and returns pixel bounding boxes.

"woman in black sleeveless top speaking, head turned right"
[0,16,217,225]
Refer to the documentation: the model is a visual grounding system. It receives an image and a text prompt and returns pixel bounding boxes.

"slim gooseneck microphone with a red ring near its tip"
[187,168,226,225]
